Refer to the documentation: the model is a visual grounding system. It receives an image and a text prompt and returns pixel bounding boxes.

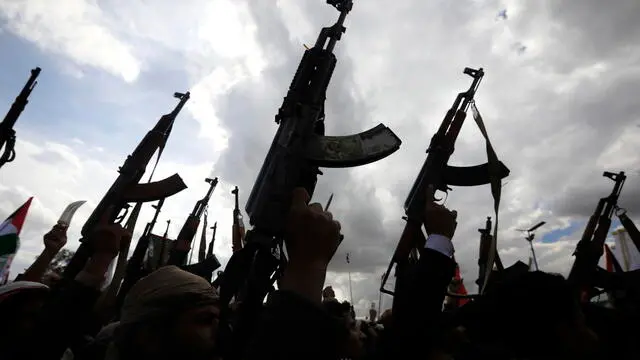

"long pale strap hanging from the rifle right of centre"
[471,101,502,294]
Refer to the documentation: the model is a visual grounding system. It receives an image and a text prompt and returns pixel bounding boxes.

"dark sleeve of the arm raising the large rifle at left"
[25,281,100,360]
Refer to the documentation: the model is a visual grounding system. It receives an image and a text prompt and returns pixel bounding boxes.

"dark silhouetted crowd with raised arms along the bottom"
[0,189,640,360]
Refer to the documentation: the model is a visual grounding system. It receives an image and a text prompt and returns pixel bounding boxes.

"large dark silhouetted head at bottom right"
[462,271,597,358]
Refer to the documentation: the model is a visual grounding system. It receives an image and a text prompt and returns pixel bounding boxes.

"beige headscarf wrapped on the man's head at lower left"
[120,266,218,326]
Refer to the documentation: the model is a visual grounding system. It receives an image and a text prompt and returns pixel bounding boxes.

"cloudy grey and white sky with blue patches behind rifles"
[0,0,640,316]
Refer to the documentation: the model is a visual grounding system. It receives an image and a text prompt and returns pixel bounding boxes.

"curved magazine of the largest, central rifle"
[306,124,402,168]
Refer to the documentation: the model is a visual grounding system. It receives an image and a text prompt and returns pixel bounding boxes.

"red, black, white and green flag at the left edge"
[0,197,33,283]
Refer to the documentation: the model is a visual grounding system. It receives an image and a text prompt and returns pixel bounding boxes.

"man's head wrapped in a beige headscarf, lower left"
[116,266,219,359]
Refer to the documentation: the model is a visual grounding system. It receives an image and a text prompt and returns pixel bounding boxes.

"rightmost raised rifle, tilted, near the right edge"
[568,171,627,297]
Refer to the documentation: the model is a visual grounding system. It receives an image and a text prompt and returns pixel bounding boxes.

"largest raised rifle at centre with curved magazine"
[220,0,401,349]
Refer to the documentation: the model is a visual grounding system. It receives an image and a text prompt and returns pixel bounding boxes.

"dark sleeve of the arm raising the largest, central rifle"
[244,290,348,360]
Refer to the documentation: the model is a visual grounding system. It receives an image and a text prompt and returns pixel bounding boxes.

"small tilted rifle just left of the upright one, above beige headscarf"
[167,178,218,266]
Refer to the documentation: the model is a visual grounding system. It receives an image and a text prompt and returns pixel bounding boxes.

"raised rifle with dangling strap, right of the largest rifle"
[380,68,509,300]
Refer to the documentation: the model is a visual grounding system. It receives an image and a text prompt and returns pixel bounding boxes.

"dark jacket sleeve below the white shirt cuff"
[379,249,455,359]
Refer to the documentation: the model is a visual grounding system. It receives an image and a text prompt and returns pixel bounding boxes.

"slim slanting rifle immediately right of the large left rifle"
[116,199,164,312]
